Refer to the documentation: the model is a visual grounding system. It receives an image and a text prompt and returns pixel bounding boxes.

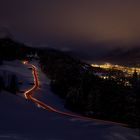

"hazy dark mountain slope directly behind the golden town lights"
[59,43,140,65]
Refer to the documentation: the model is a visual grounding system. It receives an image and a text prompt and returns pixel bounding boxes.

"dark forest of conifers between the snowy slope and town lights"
[40,51,140,127]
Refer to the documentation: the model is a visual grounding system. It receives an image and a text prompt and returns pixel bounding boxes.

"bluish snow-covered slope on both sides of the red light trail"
[0,61,139,140]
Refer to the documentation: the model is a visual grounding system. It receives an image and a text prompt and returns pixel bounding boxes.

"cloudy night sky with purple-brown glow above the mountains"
[0,0,140,56]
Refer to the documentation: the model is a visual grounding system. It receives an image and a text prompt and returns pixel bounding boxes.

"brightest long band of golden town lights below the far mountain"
[91,63,140,75]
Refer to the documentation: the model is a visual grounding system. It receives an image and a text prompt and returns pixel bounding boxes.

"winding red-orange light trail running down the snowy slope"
[23,61,128,127]
